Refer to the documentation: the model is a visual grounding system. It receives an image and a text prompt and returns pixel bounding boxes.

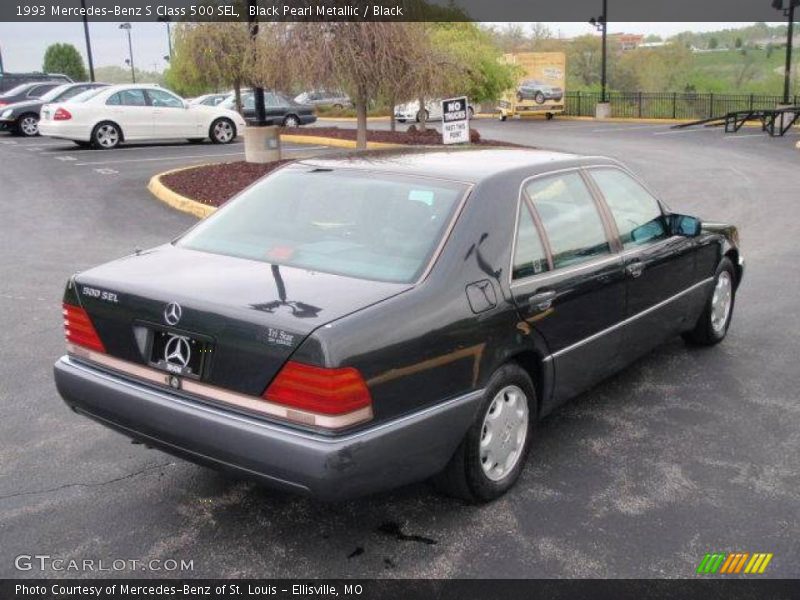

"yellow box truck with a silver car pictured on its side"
[498,52,567,121]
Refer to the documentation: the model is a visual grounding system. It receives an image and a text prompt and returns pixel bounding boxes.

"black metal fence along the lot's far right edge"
[565,92,800,119]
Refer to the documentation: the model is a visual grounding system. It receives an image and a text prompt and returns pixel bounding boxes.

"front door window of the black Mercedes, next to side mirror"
[592,169,669,248]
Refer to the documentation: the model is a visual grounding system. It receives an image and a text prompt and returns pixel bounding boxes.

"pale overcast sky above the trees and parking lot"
[0,22,781,72]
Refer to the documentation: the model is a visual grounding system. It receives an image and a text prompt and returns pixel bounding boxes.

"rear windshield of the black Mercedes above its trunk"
[177,167,466,283]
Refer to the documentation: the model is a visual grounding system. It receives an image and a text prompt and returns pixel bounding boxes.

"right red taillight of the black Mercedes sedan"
[263,361,372,415]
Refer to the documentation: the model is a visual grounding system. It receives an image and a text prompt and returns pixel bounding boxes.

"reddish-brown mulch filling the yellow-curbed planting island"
[161,125,516,206]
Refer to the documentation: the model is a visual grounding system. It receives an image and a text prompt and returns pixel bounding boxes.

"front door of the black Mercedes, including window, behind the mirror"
[589,166,695,360]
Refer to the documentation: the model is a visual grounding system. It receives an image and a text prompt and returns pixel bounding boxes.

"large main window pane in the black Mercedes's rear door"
[525,173,611,269]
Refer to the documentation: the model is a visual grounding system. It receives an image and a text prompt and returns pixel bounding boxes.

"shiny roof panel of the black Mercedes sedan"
[297,147,616,183]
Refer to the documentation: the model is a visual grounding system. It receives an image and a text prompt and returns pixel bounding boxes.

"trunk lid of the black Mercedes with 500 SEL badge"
[75,245,410,395]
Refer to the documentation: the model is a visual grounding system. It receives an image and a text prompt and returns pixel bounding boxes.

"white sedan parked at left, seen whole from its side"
[39,84,245,149]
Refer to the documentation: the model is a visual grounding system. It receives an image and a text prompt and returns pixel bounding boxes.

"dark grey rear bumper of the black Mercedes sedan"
[54,356,482,500]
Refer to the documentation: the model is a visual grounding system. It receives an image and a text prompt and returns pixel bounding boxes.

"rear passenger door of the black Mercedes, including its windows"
[511,169,625,402]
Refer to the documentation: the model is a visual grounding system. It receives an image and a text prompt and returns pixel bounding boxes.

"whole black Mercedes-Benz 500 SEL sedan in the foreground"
[55,149,743,502]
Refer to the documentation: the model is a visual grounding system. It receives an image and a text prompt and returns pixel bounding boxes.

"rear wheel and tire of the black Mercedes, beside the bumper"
[435,363,537,503]
